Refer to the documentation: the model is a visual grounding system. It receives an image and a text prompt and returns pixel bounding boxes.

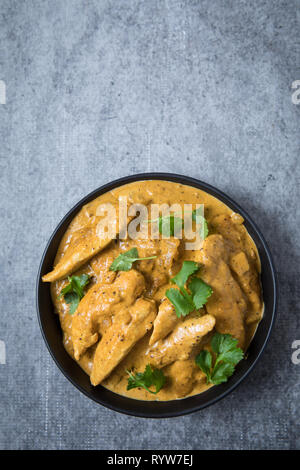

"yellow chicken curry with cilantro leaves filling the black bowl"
[43,180,263,401]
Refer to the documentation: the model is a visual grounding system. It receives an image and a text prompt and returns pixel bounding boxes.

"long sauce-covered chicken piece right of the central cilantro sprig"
[199,235,247,348]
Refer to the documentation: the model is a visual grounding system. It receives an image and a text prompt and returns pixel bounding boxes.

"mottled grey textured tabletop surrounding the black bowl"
[0,0,300,449]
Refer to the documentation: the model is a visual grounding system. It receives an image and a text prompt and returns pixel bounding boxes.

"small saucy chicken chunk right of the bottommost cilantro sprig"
[168,359,195,398]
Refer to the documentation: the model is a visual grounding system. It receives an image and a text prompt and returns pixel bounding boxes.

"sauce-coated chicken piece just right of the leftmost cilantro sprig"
[72,269,145,360]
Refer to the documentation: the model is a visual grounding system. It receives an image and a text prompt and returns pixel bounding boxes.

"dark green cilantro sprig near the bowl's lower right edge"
[195,333,244,385]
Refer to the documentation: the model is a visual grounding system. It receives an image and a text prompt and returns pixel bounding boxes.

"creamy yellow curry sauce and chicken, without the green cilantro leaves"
[43,180,263,400]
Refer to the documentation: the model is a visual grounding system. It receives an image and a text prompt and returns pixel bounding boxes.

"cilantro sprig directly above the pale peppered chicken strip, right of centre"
[166,261,212,318]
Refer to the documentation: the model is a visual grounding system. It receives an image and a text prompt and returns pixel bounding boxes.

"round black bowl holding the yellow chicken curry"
[37,173,277,418]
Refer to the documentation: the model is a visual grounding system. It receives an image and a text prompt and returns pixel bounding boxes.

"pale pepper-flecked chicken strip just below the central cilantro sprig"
[146,315,215,367]
